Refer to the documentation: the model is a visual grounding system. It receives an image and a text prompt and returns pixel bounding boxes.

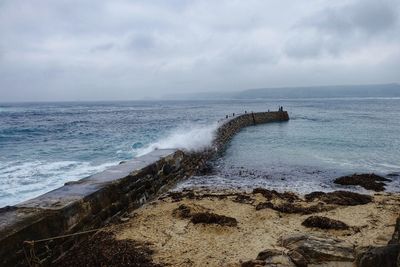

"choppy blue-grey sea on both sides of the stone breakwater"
[0,98,400,207]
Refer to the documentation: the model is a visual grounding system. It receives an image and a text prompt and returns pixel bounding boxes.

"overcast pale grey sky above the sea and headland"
[0,0,400,102]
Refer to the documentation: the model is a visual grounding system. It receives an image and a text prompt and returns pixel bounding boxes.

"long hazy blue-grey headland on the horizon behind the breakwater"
[167,83,400,100]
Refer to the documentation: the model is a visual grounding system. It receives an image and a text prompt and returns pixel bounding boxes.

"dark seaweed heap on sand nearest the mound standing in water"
[304,191,373,206]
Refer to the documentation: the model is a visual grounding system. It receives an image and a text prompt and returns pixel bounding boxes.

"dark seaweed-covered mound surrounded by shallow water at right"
[334,173,391,192]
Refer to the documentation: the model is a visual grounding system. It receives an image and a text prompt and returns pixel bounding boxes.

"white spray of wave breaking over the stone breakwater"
[137,123,218,157]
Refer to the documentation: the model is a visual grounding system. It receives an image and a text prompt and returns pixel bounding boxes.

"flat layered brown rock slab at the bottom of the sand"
[279,234,354,264]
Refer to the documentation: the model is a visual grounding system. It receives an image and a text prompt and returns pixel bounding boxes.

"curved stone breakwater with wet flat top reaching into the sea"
[0,111,289,266]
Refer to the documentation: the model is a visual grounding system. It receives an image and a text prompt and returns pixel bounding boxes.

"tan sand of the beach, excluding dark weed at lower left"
[61,189,400,266]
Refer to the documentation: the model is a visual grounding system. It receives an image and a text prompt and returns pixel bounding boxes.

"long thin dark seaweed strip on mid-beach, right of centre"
[256,202,334,214]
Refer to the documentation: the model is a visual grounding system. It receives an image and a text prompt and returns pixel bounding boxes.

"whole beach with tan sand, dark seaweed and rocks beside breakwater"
[60,188,400,266]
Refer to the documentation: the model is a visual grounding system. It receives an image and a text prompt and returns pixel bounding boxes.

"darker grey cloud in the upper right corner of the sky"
[284,0,400,59]
